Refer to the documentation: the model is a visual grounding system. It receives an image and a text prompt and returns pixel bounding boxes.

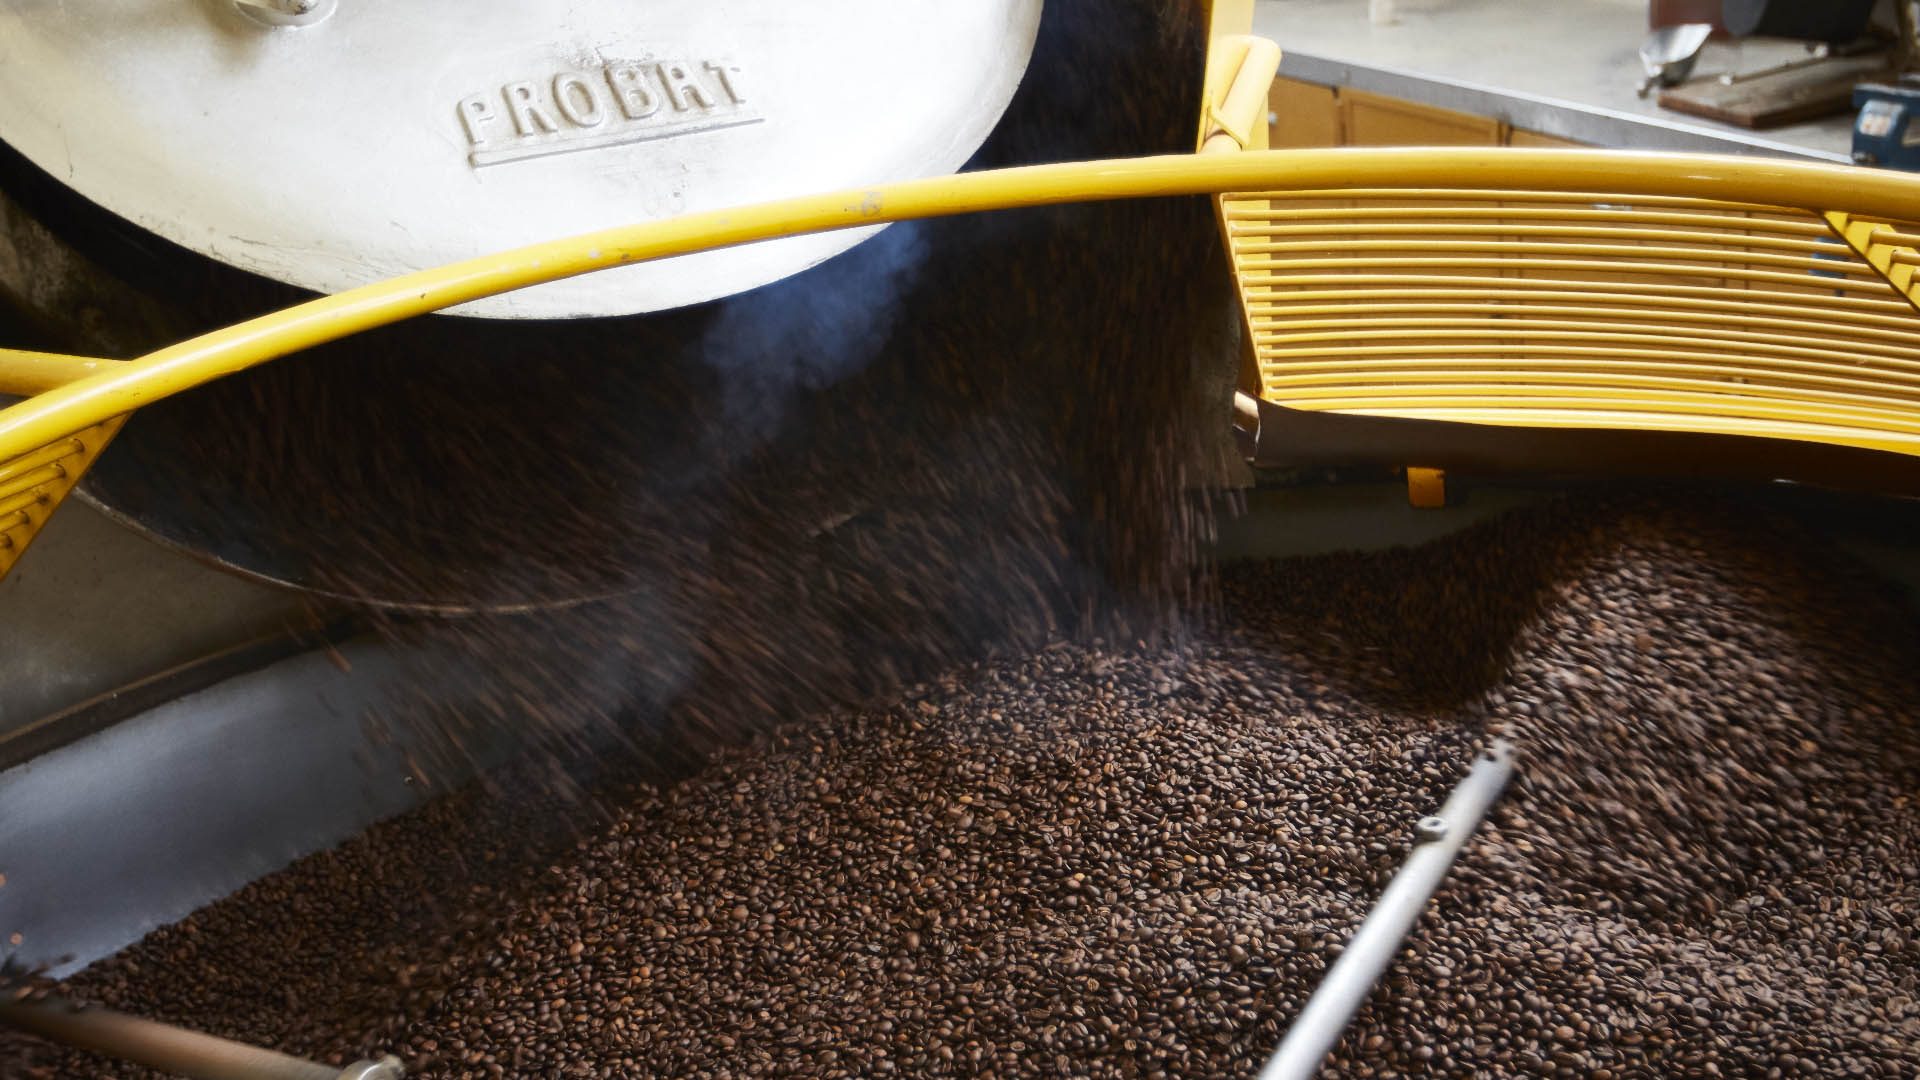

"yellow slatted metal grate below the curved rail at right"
[1219,188,1920,454]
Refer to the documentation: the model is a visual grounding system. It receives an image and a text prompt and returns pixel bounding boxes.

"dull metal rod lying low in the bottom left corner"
[0,997,401,1080]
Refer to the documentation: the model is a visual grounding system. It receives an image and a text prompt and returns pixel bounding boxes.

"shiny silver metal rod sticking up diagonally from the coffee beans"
[1260,740,1513,1080]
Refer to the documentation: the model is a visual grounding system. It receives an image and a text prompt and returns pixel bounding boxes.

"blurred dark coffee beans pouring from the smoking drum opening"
[37,0,1238,782]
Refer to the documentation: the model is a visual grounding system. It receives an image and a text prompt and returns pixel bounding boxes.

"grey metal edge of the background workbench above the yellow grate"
[1281,50,1851,165]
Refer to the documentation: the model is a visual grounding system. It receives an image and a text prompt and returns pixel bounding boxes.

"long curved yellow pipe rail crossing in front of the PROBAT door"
[11,148,1920,459]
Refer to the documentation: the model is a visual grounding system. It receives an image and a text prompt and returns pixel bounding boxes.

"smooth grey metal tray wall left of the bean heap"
[0,638,513,976]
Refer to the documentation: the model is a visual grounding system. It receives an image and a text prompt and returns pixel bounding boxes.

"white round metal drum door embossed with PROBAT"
[0,0,1041,319]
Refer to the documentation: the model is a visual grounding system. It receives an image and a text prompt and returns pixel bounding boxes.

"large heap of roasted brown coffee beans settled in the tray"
[0,490,1920,1080]
